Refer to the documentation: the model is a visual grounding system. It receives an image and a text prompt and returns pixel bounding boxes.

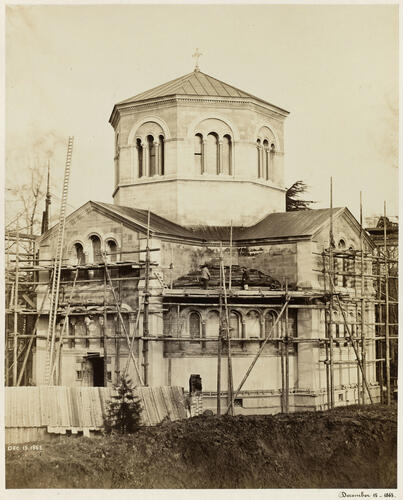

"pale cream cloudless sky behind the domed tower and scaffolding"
[6,5,398,223]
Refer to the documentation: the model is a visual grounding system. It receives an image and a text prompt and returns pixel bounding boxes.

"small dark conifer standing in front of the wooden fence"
[104,376,142,434]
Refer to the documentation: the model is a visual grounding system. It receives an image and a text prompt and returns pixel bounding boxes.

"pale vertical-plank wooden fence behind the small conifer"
[5,386,188,444]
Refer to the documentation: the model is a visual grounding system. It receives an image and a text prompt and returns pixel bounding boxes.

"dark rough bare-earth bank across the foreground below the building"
[6,406,397,488]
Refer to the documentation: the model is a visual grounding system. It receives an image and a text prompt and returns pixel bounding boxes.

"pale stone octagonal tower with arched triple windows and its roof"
[110,69,288,226]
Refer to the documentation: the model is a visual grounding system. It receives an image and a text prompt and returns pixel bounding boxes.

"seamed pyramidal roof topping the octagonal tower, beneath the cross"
[118,71,278,104]
